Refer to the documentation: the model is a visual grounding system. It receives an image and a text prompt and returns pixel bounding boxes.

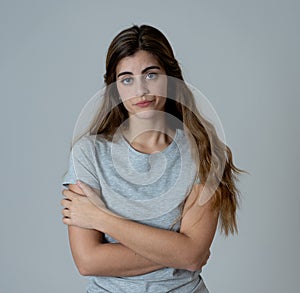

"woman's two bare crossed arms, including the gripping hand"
[62,184,218,277]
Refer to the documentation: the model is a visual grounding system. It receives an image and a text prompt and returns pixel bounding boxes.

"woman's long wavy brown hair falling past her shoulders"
[77,25,241,235]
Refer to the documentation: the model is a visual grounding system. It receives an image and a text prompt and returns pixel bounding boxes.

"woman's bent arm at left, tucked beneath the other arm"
[63,184,163,276]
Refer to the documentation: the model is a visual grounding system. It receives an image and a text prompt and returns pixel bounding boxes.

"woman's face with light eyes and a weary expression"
[116,50,167,119]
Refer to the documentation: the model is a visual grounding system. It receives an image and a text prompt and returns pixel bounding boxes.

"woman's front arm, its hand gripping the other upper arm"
[64,184,218,271]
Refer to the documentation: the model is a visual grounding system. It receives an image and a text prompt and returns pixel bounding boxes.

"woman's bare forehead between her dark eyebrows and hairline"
[116,50,161,74]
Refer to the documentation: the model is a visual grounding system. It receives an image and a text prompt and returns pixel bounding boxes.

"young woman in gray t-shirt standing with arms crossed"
[62,25,240,292]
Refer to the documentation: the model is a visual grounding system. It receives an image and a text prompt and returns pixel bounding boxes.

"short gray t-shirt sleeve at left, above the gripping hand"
[62,138,100,189]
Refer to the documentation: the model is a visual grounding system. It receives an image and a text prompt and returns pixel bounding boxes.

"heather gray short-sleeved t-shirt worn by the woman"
[63,129,208,293]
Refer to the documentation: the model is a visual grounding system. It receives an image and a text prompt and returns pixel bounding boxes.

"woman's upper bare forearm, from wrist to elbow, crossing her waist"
[99,215,206,269]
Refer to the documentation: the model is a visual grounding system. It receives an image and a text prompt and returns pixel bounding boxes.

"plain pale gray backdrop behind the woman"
[0,0,300,293]
